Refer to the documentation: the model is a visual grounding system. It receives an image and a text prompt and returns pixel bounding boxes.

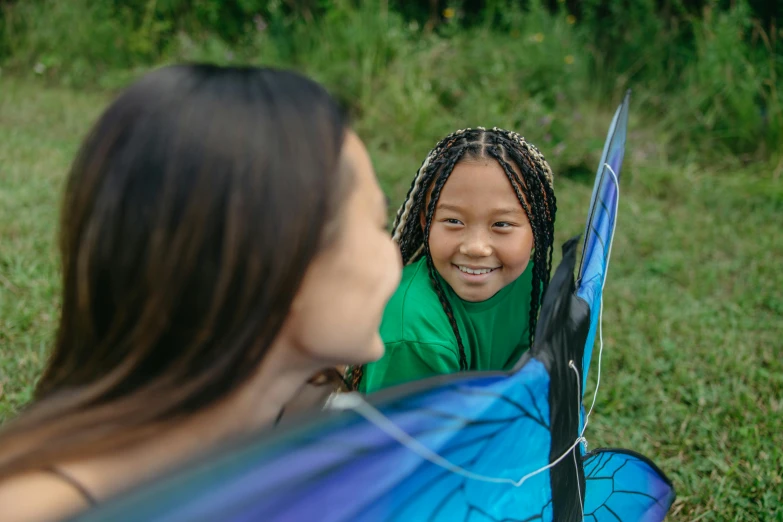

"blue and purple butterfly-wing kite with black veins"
[72,90,675,522]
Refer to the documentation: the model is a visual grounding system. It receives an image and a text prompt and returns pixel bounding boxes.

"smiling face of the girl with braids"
[421,160,533,302]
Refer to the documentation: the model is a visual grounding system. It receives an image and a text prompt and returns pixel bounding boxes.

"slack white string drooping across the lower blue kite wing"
[331,361,584,490]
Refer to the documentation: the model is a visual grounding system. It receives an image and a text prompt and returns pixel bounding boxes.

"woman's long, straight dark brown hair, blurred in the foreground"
[0,65,351,478]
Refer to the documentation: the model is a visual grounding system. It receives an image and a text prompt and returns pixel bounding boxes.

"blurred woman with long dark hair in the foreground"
[0,65,400,521]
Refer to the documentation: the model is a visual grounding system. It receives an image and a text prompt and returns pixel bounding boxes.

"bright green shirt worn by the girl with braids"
[359,258,533,393]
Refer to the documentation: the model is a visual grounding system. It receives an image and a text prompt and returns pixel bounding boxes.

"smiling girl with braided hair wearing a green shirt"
[352,127,556,393]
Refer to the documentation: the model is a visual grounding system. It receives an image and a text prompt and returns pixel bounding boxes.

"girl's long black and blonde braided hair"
[350,127,557,389]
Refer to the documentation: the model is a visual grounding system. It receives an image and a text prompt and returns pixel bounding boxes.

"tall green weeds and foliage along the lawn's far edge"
[0,0,783,162]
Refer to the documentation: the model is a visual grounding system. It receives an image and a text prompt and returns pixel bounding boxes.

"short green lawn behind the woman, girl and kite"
[0,78,783,521]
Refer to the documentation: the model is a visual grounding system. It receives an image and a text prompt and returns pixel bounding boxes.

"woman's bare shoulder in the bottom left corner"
[0,472,89,522]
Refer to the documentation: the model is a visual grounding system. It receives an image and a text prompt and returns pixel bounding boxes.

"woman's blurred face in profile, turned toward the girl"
[285,132,402,367]
